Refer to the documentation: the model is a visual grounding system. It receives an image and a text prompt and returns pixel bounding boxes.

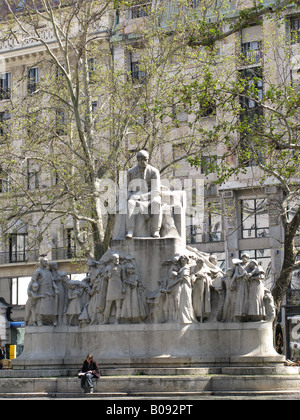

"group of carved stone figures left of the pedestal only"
[25,253,147,326]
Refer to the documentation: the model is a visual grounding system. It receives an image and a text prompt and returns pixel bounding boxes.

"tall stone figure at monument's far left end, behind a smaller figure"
[27,257,59,326]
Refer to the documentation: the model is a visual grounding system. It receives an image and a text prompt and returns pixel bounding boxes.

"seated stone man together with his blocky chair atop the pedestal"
[112,150,186,244]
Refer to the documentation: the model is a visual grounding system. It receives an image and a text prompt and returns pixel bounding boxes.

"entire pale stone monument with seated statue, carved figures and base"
[14,151,284,368]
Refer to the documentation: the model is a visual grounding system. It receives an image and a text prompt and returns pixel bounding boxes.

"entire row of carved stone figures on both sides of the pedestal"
[25,252,275,327]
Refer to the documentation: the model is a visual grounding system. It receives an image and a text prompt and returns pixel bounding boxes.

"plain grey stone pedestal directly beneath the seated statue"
[111,238,183,292]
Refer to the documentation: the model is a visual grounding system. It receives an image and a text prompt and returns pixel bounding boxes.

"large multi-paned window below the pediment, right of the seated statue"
[241,199,269,239]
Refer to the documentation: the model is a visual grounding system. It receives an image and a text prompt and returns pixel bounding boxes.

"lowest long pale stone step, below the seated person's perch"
[0,374,300,395]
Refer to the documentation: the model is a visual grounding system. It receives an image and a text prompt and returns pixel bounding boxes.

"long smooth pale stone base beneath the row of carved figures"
[13,322,284,369]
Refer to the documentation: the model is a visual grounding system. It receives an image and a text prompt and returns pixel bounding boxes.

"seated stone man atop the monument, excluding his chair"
[126,150,162,238]
